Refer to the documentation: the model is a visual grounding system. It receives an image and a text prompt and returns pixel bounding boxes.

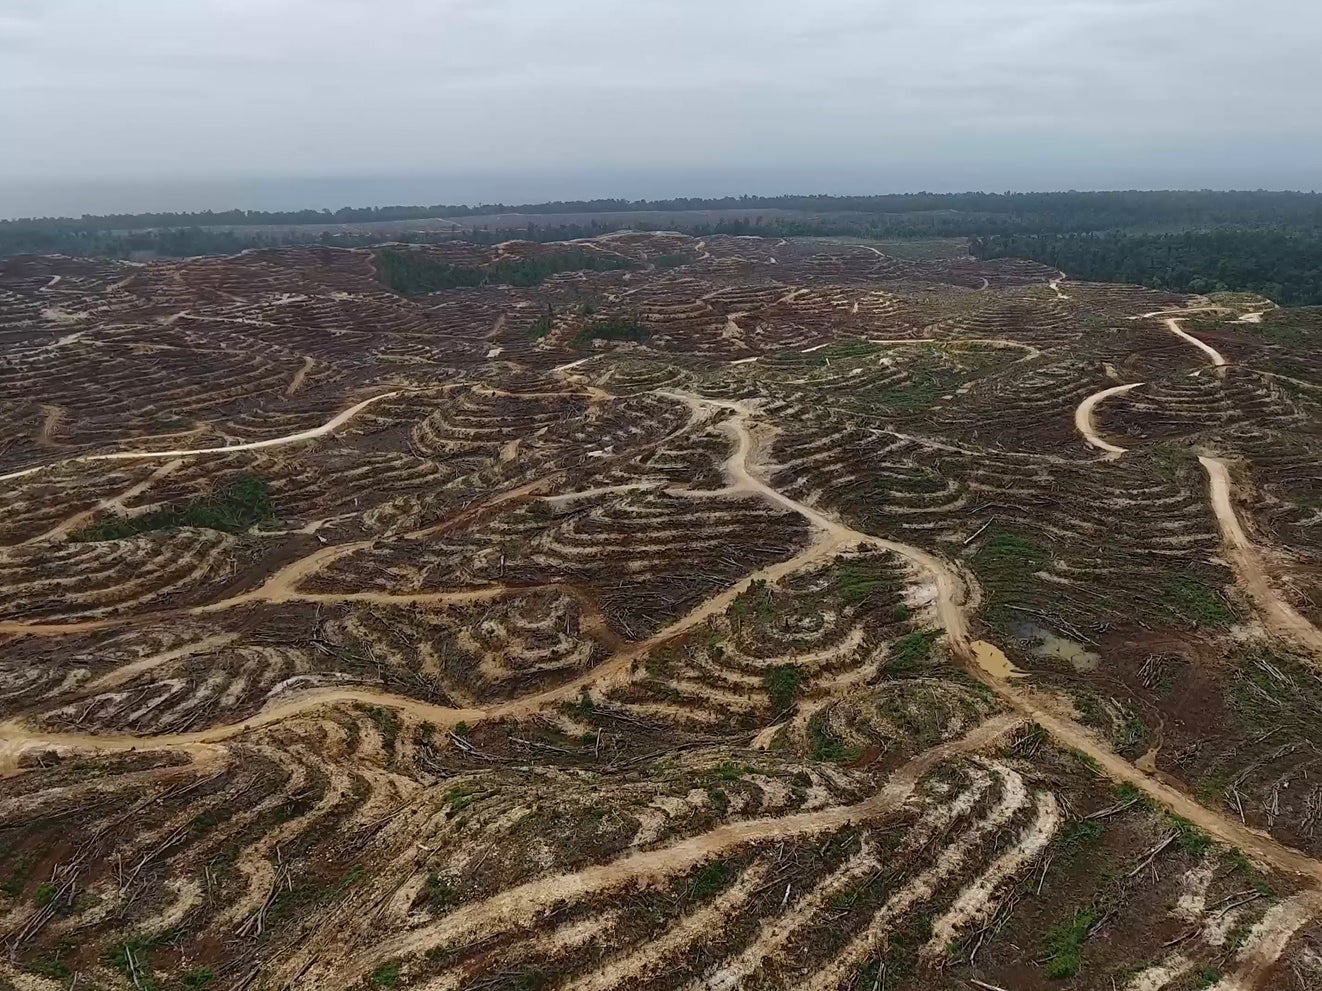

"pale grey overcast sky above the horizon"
[0,0,1322,215]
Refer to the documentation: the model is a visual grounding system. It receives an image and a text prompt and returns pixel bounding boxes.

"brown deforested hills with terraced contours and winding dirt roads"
[0,234,1322,991]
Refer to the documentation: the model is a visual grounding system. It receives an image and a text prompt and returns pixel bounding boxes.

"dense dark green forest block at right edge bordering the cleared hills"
[970,227,1322,307]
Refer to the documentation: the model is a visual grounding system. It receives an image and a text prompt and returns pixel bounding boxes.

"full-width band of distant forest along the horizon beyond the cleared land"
[0,190,1322,305]
